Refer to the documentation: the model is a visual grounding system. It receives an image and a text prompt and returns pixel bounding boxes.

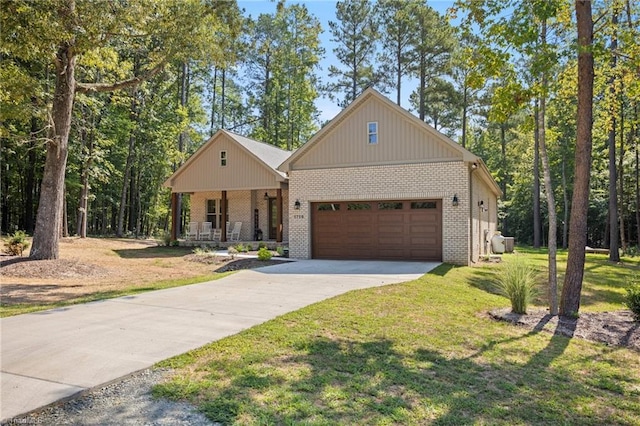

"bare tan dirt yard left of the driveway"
[0,238,281,306]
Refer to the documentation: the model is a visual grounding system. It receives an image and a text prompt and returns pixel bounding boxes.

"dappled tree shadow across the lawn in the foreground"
[164,322,615,425]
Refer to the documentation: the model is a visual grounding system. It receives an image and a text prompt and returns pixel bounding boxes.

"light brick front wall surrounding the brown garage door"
[289,161,470,265]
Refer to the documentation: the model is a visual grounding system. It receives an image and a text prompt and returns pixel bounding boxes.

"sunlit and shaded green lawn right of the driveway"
[154,251,640,425]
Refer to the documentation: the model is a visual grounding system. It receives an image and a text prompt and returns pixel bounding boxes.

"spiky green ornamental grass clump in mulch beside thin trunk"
[496,256,537,314]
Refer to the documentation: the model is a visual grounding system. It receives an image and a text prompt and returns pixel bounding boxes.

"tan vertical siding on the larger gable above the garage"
[293,97,462,170]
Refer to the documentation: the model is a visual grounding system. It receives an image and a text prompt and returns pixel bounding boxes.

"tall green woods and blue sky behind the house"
[0,0,640,260]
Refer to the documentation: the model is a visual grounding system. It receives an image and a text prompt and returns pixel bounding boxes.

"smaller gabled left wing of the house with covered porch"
[164,130,291,242]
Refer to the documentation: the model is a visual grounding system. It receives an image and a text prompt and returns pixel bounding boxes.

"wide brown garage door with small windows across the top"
[311,200,442,261]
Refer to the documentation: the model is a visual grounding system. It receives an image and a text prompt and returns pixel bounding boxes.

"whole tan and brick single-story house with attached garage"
[165,88,501,265]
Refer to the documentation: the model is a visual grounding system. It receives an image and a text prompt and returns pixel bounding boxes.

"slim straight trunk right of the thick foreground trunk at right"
[608,8,620,262]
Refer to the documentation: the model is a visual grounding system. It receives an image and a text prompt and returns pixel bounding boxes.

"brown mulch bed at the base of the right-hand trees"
[489,308,640,352]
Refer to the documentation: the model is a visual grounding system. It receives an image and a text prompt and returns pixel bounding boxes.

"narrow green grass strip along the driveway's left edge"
[0,272,233,318]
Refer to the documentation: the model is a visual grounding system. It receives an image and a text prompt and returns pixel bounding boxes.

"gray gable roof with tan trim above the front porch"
[163,130,291,188]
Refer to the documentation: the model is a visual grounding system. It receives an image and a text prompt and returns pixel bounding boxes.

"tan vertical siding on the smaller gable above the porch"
[166,134,275,192]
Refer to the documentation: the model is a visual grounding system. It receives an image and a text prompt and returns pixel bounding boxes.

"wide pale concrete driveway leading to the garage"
[0,260,438,422]
